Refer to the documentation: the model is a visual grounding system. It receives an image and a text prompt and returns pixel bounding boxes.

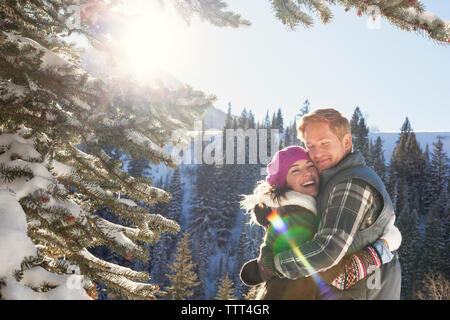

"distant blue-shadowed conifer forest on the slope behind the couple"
[89,101,450,299]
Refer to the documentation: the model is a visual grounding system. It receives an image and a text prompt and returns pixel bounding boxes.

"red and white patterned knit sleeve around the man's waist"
[331,246,381,290]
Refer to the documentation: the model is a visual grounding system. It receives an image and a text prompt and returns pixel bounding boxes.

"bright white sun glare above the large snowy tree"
[112,0,191,79]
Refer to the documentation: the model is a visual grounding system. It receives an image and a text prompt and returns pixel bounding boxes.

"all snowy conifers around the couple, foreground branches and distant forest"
[0,0,450,300]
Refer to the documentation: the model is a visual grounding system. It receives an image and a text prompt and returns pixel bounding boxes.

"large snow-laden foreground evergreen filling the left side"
[0,0,243,299]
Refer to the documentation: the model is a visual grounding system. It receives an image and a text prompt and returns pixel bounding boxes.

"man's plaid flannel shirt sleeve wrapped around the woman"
[274,179,377,279]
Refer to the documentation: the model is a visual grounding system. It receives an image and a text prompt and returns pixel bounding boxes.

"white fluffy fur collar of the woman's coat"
[240,181,317,214]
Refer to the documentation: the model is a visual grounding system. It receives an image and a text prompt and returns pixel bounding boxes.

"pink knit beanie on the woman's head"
[266,146,311,187]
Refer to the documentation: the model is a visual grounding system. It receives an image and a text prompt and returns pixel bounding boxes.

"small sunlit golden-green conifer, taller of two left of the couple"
[165,232,200,300]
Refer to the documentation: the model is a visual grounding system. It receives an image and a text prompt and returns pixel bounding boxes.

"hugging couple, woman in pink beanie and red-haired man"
[241,109,401,300]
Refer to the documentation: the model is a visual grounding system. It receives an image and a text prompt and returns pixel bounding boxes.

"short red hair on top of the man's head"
[297,108,350,141]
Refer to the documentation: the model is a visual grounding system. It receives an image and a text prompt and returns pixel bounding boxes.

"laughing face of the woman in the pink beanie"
[286,160,319,197]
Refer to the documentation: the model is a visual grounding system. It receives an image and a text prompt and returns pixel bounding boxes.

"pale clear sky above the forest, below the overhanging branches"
[154,0,450,131]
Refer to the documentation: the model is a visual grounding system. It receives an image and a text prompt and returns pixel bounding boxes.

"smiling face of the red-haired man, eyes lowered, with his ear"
[304,122,352,172]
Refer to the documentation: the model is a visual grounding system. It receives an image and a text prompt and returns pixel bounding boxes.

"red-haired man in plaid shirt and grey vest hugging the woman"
[273,109,401,299]
